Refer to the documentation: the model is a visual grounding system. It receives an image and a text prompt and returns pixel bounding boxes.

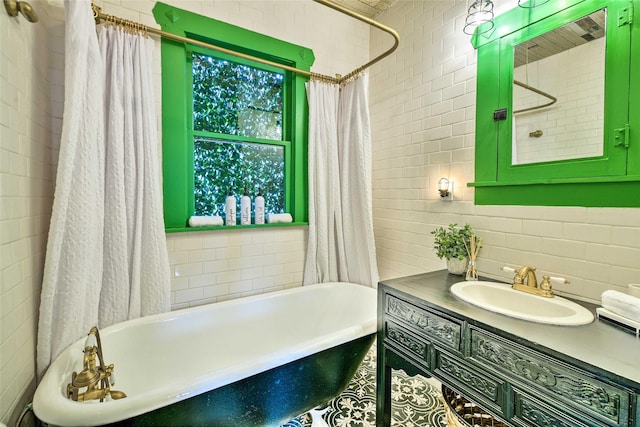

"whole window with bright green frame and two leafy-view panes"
[153,3,314,232]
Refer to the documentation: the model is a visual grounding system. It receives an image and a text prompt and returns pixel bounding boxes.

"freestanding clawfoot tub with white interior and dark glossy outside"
[33,283,376,427]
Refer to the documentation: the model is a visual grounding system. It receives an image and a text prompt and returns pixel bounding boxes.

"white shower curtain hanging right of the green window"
[304,73,378,287]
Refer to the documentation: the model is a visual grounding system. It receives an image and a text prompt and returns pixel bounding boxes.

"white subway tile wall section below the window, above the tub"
[167,227,307,309]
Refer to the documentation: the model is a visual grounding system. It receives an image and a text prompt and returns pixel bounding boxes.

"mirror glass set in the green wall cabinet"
[511,9,606,165]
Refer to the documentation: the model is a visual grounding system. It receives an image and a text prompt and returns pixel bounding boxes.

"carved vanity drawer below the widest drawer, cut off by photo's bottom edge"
[511,389,608,427]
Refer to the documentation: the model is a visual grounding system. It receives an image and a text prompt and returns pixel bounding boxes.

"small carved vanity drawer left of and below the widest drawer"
[434,351,506,414]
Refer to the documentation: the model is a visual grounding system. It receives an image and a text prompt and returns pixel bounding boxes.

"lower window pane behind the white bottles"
[193,137,285,216]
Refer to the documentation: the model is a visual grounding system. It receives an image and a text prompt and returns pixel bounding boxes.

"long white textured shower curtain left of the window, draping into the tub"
[37,0,170,377]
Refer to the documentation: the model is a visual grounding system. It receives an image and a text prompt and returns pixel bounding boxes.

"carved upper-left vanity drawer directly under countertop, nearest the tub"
[385,294,462,351]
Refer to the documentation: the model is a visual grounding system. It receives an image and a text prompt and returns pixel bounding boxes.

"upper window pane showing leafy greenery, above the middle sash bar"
[192,54,284,141]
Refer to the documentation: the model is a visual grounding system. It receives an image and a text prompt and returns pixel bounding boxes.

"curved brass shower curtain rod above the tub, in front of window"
[91,0,400,84]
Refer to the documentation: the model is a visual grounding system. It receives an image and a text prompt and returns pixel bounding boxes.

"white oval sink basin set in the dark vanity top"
[451,281,593,326]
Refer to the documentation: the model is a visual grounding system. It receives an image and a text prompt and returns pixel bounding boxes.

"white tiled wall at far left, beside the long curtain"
[0,1,61,425]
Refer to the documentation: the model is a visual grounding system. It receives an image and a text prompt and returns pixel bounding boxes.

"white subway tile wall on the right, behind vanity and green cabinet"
[370,0,640,301]
